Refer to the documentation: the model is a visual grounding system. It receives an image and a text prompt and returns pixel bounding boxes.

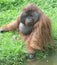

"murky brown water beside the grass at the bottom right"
[26,53,57,65]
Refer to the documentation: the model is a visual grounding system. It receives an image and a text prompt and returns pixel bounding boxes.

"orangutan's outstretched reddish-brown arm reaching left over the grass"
[0,17,20,32]
